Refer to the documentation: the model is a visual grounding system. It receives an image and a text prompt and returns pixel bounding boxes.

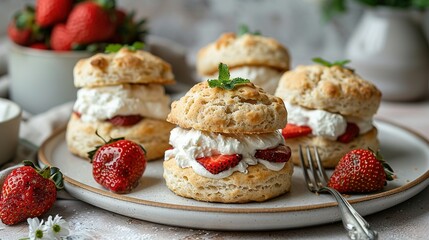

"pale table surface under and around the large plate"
[0,99,429,240]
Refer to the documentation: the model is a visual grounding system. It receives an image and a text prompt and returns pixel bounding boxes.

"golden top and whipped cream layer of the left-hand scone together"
[73,47,175,122]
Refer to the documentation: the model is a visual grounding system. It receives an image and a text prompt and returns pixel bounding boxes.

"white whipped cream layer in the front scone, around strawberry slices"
[165,127,285,179]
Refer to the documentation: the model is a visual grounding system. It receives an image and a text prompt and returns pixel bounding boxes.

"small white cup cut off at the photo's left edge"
[0,98,22,165]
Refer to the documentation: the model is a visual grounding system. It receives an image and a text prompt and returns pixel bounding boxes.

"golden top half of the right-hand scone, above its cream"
[275,65,381,118]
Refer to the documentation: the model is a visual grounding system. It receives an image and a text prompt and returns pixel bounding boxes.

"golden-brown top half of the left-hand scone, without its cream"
[73,48,175,88]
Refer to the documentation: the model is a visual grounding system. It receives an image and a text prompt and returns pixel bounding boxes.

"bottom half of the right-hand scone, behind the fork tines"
[286,127,380,168]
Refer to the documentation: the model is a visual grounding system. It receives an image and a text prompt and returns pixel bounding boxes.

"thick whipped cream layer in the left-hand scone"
[73,84,170,122]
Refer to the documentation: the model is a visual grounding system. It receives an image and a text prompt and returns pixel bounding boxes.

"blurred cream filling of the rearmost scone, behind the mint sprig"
[202,66,282,94]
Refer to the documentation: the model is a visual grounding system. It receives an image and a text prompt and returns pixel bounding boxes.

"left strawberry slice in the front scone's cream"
[196,154,242,174]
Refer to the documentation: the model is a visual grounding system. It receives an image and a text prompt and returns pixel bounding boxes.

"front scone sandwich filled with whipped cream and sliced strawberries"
[163,67,293,203]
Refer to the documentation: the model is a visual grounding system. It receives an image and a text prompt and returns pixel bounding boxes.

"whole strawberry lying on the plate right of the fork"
[328,149,395,193]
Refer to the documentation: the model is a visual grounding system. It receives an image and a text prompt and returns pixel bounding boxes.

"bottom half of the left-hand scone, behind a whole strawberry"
[66,113,175,160]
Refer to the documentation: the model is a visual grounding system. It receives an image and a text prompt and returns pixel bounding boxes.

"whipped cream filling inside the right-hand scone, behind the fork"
[285,102,373,140]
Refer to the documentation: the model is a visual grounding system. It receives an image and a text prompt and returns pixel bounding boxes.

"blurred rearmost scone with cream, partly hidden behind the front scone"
[196,33,290,94]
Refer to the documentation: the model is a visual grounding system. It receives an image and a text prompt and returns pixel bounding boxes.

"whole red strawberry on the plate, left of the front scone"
[88,133,146,193]
